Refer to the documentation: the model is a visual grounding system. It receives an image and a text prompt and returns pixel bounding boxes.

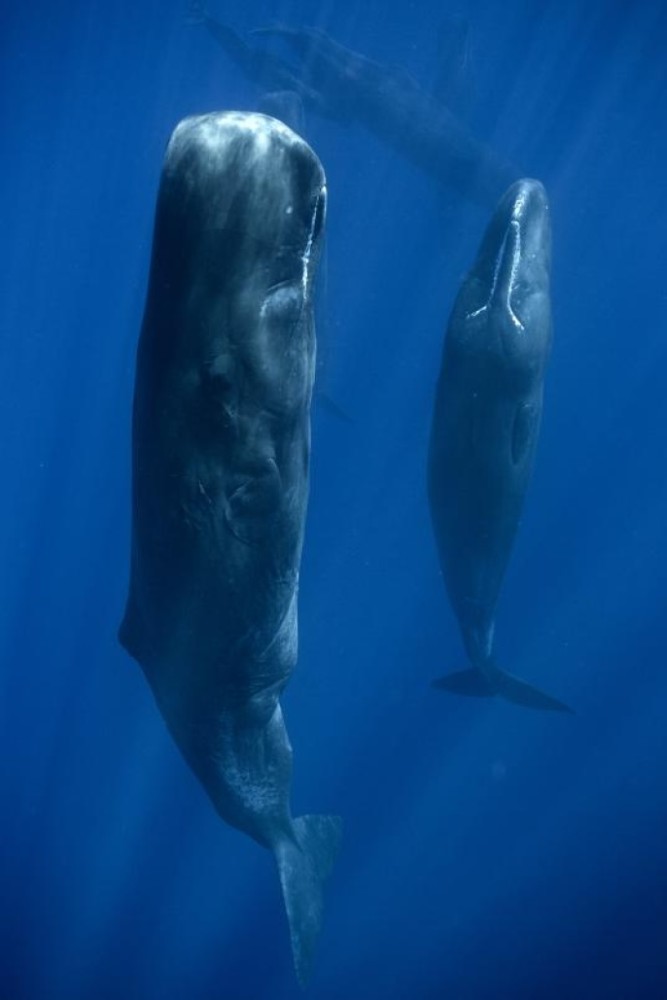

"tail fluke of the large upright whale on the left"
[275,816,341,986]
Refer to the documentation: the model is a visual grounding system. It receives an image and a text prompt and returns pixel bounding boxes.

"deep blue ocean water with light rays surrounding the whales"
[0,0,667,1000]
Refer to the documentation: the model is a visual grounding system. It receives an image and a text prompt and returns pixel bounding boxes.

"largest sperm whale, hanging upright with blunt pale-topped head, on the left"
[119,113,340,982]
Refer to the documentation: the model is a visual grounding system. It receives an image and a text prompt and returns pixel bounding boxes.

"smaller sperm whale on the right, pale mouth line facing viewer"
[428,180,569,711]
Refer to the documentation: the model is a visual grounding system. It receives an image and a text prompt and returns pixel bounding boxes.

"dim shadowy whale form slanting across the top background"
[191,3,518,208]
